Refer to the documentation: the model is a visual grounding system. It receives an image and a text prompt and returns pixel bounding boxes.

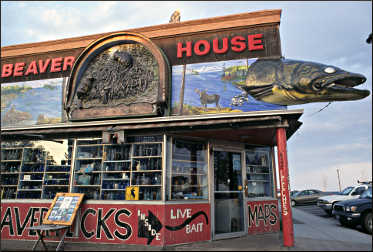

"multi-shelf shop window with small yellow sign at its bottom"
[73,136,163,200]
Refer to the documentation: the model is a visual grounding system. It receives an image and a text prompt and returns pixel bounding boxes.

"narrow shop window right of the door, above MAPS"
[246,147,273,198]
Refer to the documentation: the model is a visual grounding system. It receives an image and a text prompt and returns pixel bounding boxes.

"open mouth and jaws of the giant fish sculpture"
[311,73,370,100]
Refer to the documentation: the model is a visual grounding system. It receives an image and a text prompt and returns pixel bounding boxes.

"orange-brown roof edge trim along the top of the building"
[1,9,282,58]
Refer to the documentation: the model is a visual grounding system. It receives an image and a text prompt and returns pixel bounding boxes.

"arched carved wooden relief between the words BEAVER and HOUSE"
[65,33,170,120]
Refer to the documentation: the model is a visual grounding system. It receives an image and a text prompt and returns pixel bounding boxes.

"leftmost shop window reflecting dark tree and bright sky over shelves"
[1,139,72,199]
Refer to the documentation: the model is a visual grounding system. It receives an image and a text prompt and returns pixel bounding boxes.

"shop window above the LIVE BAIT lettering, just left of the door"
[167,138,208,200]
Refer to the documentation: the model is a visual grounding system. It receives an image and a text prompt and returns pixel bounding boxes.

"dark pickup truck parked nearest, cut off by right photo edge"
[332,186,372,234]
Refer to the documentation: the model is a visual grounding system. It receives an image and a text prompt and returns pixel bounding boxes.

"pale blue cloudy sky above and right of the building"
[1,1,372,190]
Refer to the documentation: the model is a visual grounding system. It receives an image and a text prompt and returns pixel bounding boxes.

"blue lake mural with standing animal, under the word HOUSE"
[171,59,287,115]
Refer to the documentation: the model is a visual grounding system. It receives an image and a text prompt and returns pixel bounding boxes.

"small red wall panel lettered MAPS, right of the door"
[247,200,280,234]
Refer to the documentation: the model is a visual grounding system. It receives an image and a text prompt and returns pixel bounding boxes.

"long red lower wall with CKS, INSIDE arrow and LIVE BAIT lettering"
[1,202,210,246]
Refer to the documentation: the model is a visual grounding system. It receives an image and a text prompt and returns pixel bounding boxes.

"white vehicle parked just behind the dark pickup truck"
[317,182,372,216]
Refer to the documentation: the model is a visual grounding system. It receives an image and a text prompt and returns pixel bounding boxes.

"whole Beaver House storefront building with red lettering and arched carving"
[1,10,303,246]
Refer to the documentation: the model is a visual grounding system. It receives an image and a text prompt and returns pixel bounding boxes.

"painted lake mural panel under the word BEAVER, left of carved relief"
[1,78,63,127]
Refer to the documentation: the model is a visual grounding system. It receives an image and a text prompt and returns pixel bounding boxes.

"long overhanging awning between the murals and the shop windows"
[1,109,303,146]
